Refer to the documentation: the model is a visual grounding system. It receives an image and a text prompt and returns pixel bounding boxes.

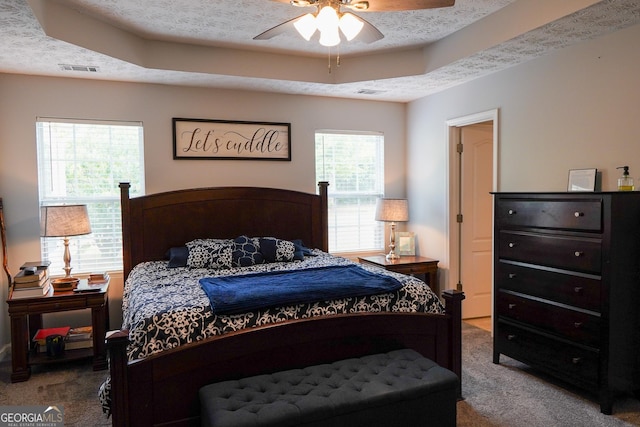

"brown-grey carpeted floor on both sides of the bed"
[0,324,640,427]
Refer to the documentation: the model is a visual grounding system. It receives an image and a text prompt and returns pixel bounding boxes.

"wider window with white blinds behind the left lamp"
[36,118,144,274]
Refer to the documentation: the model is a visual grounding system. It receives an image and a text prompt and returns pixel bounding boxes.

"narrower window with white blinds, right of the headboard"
[316,131,384,252]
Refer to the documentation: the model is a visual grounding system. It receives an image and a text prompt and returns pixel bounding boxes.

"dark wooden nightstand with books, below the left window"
[7,281,109,383]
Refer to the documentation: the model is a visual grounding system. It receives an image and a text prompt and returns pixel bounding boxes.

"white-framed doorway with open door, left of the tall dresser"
[447,110,498,319]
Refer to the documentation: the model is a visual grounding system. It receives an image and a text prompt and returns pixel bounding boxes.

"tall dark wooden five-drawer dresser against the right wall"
[493,192,640,414]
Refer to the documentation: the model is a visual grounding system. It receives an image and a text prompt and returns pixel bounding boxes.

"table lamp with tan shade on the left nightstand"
[40,205,91,287]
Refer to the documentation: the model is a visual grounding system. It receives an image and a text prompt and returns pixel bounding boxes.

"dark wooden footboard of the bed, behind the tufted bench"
[107,291,464,426]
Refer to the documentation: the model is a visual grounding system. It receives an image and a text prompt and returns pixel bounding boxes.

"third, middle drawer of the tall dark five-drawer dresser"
[495,260,601,312]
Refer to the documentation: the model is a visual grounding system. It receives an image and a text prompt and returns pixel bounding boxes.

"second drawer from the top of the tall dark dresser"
[497,230,602,274]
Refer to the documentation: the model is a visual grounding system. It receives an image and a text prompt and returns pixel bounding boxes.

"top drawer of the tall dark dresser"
[495,199,602,231]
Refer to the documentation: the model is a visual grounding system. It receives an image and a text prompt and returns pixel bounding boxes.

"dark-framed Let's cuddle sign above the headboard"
[173,118,291,161]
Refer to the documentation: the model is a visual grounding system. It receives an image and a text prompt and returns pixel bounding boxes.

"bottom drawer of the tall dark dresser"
[494,322,599,387]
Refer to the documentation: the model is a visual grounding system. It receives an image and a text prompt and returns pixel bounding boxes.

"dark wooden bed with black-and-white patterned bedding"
[107,182,464,426]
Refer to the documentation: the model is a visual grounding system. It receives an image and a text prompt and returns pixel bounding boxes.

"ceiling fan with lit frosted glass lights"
[253,0,455,47]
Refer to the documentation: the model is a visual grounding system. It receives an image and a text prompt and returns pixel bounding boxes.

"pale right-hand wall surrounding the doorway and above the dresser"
[407,25,640,289]
